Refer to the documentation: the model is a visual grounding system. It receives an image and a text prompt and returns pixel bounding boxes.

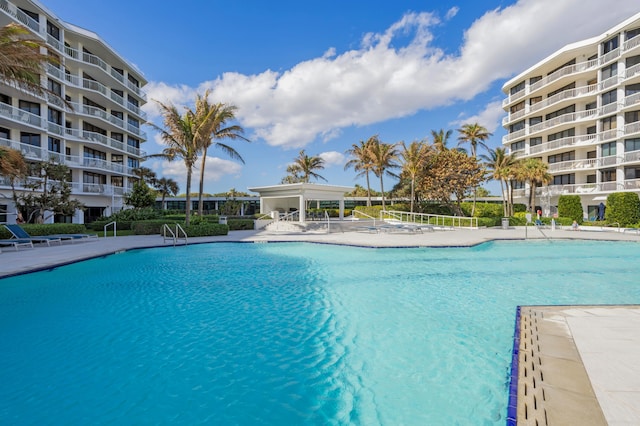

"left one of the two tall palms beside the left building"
[149,101,199,226]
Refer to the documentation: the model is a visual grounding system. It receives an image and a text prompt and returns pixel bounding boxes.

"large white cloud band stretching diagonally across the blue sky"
[146,0,640,148]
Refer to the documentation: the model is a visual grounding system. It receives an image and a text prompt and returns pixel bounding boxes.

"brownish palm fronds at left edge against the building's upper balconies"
[0,24,73,109]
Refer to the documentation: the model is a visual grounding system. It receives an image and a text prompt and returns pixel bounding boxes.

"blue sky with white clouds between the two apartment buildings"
[40,0,640,194]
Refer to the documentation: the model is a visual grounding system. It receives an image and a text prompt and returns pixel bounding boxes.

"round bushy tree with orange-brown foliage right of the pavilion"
[420,149,485,216]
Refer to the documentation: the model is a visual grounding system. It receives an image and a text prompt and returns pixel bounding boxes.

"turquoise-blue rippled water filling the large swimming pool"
[0,241,640,425]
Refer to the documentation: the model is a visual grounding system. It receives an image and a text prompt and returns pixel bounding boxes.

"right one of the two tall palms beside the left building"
[195,90,249,215]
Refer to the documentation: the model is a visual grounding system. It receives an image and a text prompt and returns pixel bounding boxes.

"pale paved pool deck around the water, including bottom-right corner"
[0,227,640,425]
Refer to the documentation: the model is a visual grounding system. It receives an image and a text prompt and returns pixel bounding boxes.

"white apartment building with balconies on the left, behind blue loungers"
[0,0,146,223]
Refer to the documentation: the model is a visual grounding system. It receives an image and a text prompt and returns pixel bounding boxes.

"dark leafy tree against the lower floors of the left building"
[15,160,84,223]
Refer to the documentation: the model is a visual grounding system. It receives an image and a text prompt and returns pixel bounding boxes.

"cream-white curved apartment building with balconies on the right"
[502,14,640,217]
